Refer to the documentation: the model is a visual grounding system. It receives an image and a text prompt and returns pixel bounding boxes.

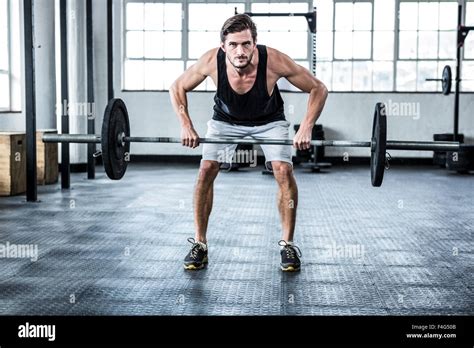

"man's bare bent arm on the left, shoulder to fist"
[169,49,217,148]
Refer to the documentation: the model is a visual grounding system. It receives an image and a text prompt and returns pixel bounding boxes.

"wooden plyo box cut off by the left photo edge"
[0,132,26,196]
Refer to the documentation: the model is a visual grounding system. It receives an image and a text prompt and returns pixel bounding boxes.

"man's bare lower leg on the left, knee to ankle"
[194,160,219,244]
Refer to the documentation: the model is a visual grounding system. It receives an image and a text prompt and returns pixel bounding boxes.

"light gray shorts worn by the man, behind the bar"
[202,120,293,170]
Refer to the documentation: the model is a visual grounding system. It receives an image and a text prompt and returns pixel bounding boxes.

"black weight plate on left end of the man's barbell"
[102,99,130,180]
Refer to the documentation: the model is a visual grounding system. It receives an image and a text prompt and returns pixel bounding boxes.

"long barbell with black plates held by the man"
[42,99,460,187]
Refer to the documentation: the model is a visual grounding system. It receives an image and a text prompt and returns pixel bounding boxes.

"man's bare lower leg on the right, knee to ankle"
[272,161,298,242]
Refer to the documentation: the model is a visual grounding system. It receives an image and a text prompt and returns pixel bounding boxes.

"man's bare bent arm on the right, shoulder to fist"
[269,49,328,149]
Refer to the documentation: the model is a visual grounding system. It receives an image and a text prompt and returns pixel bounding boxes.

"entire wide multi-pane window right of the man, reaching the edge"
[316,0,474,92]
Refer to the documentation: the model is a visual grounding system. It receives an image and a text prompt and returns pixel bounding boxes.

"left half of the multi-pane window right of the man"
[316,0,395,92]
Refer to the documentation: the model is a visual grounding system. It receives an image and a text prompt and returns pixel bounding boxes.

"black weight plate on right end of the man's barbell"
[370,103,387,187]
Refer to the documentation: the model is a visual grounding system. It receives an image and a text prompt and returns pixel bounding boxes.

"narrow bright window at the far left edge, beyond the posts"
[0,0,21,112]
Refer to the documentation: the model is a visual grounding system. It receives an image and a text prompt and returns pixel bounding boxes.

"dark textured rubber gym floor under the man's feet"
[0,163,474,315]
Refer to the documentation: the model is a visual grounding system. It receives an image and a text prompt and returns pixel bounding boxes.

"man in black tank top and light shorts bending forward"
[170,14,327,271]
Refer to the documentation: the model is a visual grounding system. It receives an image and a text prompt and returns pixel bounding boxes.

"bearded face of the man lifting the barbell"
[221,29,255,69]
